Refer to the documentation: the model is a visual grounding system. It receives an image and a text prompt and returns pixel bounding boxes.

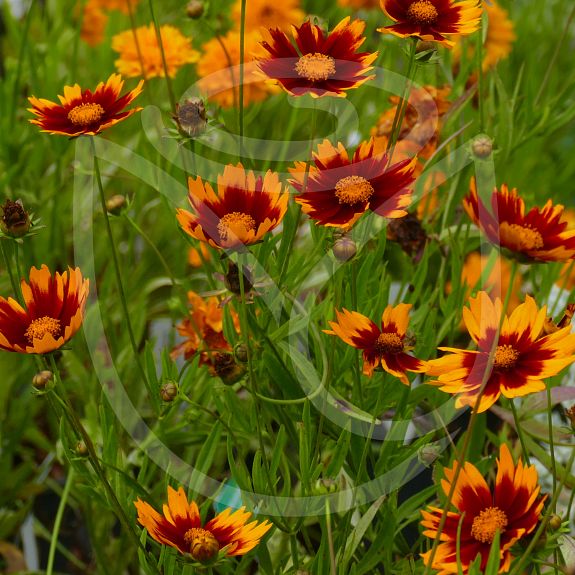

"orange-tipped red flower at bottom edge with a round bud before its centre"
[134,487,272,564]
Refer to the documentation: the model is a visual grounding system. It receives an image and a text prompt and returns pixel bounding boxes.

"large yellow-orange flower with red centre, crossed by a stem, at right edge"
[427,291,575,413]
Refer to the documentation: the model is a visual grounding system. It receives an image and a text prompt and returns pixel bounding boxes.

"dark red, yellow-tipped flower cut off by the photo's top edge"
[378,0,482,48]
